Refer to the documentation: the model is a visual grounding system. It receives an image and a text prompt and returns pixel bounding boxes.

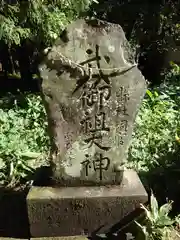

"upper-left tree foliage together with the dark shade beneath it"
[0,0,96,78]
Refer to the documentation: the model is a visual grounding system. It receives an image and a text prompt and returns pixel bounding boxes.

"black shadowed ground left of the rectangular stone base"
[0,188,30,238]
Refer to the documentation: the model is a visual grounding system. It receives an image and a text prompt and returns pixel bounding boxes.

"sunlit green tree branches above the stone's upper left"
[0,0,95,45]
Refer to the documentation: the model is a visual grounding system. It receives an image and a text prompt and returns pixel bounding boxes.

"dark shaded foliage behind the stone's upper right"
[90,0,180,83]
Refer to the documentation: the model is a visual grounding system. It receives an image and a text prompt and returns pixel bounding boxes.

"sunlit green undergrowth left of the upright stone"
[0,95,49,186]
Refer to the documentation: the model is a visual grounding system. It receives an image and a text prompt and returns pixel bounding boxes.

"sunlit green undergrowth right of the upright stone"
[129,63,180,171]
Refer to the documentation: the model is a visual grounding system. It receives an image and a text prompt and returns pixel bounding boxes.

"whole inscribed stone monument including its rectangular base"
[27,19,147,237]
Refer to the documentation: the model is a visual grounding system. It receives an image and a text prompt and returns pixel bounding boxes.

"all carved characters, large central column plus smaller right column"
[77,45,130,180]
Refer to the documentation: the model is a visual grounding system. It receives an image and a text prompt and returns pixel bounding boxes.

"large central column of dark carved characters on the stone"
[80,45,111,181]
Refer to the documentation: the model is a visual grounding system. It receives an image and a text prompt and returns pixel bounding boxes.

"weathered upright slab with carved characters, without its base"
[40,20,146,185]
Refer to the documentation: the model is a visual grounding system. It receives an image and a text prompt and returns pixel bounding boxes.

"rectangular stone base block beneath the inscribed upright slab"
[27,170,148,237]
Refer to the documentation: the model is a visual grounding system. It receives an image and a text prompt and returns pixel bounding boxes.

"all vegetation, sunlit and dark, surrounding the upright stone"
[0,0,180,238]
